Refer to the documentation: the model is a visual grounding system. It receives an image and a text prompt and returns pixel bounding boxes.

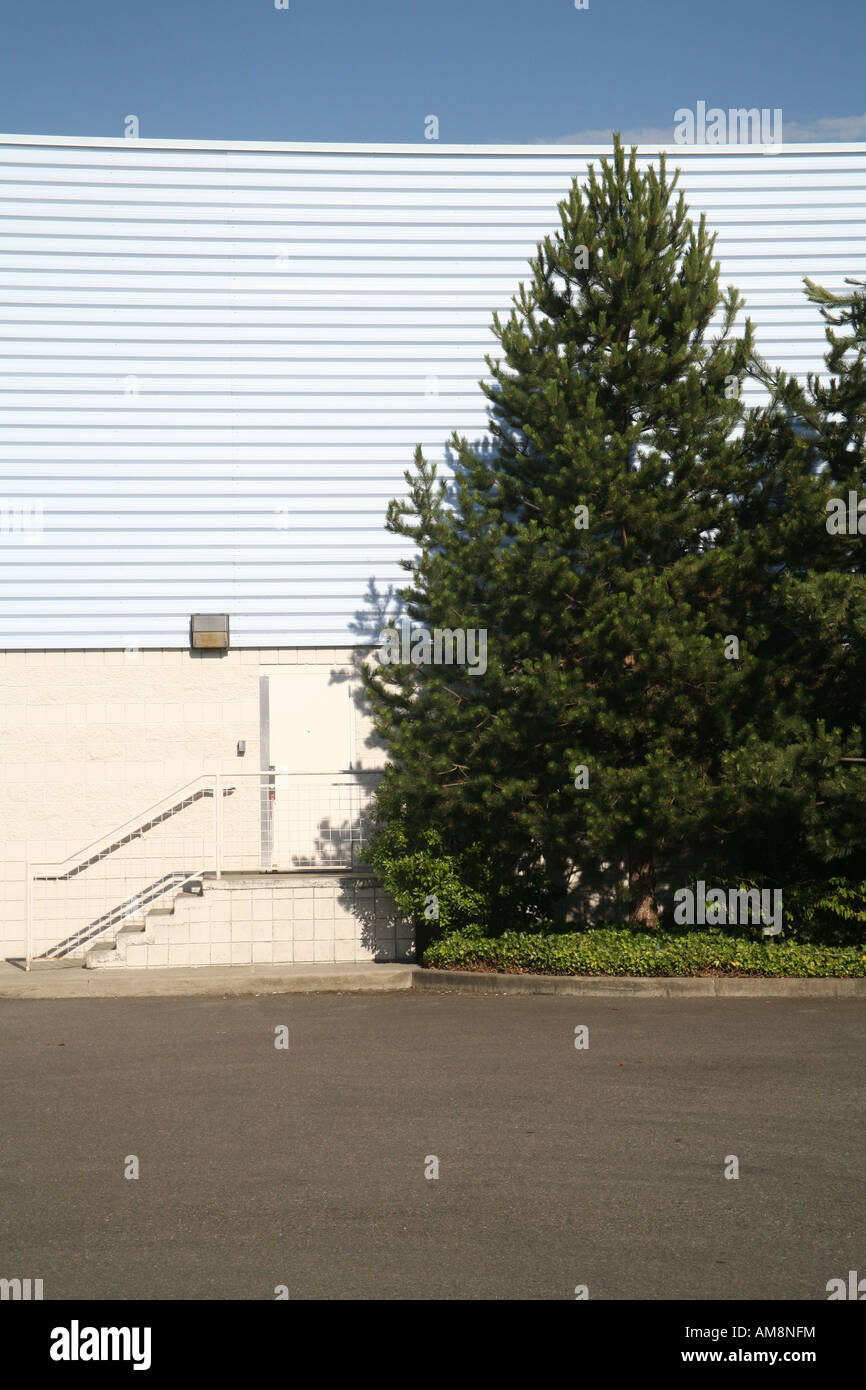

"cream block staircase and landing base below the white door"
[83,870,414,970]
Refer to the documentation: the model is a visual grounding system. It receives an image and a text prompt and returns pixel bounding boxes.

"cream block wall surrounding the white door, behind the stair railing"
[0,648,381,956]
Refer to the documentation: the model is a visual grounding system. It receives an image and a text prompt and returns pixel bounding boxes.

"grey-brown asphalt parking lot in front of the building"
[0,992,866,1300]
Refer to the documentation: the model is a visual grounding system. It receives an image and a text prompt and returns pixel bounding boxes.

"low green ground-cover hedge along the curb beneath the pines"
[423,927,866,976]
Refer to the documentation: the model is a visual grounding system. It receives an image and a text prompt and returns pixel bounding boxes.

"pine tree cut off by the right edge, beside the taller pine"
[719,279,866,884]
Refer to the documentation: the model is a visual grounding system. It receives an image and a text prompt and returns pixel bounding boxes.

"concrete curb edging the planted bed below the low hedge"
[411,966,866,999]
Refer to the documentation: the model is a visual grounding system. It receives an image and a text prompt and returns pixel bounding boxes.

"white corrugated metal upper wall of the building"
[0,136,866,648]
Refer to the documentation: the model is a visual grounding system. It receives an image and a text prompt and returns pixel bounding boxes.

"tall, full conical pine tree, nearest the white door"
[366,138,753,924]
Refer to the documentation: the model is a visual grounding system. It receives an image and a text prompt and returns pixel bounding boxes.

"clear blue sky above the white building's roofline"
[0,0,866,143]
